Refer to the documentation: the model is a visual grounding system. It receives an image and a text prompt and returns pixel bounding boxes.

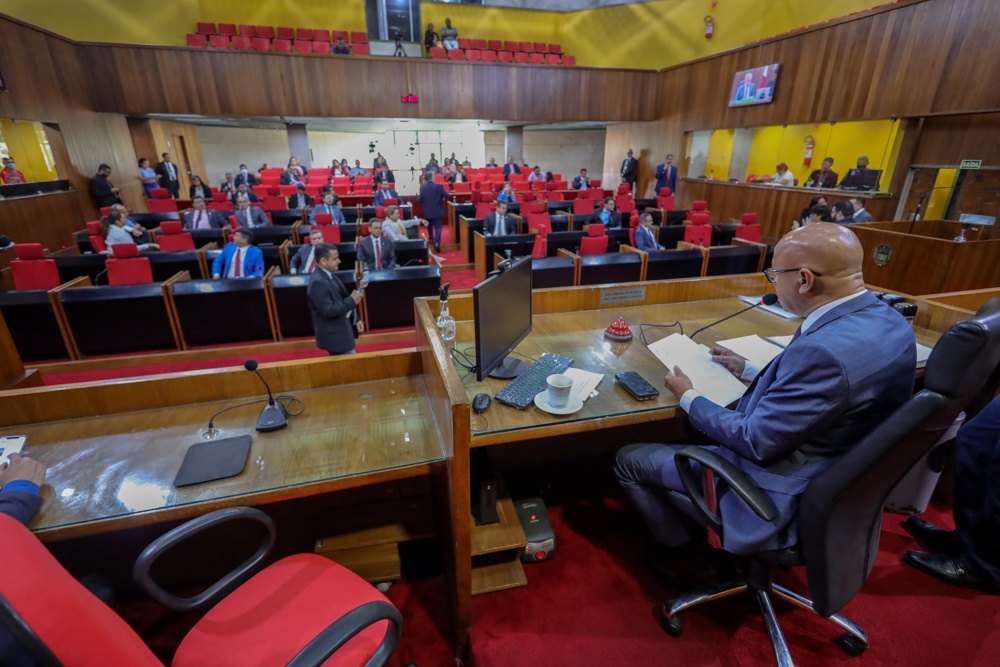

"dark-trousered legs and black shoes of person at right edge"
[902,398,1000,595]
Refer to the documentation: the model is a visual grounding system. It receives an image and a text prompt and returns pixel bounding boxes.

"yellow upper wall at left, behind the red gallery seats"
[2,0,366,45]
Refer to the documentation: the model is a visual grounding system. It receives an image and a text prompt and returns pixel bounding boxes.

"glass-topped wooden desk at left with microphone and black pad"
[0,352,445,541]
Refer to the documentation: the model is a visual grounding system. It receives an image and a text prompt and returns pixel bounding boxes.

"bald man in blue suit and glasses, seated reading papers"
[615,223,916,560]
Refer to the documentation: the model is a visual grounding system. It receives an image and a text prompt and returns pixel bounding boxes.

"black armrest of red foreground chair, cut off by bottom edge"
[286,600,403,667]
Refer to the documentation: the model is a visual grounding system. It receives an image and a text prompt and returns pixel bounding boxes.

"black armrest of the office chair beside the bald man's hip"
[674,447,778,535]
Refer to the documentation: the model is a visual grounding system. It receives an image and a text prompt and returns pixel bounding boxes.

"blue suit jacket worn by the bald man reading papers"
[690,293,917,554]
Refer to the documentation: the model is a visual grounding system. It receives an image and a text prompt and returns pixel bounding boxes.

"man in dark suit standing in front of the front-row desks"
[307,243,365,357]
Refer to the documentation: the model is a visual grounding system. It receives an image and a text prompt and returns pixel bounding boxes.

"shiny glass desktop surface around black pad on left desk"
[17,376,444,532]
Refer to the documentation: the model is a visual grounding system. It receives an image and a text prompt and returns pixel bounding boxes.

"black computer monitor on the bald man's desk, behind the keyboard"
[472,257,531,382]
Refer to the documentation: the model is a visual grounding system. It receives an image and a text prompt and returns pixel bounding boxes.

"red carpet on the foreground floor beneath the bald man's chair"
[119,459,1000,667]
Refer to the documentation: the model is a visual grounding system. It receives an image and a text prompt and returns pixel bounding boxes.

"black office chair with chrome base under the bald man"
[660,298,1000,667]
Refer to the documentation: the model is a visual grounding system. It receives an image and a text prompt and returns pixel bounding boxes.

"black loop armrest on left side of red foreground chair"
[132,507,275,612]
